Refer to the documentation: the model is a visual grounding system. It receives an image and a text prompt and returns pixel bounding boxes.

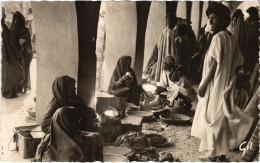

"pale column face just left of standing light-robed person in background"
[143,1,166,70]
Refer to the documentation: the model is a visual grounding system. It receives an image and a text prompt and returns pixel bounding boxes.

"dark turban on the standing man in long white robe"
[206,2,230,30]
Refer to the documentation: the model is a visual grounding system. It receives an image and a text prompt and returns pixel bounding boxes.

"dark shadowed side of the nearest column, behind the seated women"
[75,1,101,107]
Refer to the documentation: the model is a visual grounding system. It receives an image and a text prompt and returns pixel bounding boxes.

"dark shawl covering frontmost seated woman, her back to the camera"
[42,107,103,162]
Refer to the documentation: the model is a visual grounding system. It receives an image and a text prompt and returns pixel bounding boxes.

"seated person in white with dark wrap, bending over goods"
[160,56,197,109]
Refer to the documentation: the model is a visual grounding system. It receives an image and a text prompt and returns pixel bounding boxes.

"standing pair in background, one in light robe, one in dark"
[144,13,196,82]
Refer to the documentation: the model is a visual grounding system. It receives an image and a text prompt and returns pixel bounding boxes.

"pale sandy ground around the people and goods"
[1,59,242,162]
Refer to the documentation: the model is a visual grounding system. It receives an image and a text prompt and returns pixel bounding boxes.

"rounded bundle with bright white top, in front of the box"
[100,107,122,142]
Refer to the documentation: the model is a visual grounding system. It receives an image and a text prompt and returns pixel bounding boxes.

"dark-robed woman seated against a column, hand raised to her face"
[108,56,141,105]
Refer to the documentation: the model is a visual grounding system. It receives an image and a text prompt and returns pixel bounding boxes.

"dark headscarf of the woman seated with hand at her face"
[108,56,132,92]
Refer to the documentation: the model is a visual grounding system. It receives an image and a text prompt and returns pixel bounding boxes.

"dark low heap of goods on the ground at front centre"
[115,131,150,151]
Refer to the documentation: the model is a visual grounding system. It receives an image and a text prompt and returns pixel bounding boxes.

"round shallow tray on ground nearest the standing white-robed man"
[160,113,191,124]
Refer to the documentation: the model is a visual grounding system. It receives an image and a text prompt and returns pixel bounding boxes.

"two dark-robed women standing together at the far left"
[1,8,33,98]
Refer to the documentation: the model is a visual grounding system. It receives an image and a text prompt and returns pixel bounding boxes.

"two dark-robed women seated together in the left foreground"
[35,76,103,162]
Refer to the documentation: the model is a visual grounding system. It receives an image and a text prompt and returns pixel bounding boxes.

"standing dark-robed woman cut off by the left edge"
[1,8,24,98]
